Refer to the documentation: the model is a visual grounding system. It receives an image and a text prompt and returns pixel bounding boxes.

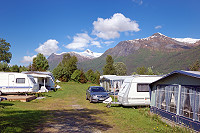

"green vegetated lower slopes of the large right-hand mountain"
[78,46,200,75]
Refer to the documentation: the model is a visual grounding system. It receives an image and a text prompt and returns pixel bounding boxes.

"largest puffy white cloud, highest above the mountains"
[92,13,140,40]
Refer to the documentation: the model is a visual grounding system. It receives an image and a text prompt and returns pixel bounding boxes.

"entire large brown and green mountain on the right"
[78,33,200,74]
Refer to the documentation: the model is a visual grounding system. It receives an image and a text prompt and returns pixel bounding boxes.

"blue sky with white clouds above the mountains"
[0,0,200,66]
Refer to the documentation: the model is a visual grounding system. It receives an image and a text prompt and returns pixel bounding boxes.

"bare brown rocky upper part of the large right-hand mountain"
[104,33,197,57]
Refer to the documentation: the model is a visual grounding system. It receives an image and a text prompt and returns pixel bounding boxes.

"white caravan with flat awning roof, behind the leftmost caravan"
[22,71,55,92]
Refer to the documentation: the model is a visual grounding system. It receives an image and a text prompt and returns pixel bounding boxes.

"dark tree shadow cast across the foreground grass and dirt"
[0,109,112,133]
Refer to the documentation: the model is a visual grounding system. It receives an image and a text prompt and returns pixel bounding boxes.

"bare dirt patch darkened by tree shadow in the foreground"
[35,104,112,133]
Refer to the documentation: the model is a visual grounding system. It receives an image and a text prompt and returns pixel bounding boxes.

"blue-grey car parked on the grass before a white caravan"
[86,86,110,103]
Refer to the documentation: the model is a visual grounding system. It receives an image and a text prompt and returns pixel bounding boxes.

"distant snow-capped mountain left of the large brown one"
[47,49,102,70]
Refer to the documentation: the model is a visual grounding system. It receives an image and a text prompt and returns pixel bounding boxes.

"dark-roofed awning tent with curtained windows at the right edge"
[150,71,200,131]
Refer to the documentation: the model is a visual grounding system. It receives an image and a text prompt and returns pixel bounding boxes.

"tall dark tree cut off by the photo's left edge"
[0,38,12,63]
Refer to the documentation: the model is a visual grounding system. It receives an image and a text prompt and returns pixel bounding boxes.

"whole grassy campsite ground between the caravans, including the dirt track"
[0,82,189,133]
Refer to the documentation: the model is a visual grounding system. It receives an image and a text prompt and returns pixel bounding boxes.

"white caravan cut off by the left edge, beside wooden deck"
[0,72,39,95]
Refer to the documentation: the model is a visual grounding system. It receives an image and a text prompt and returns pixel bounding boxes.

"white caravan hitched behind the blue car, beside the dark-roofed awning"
[118,75,162,106]
